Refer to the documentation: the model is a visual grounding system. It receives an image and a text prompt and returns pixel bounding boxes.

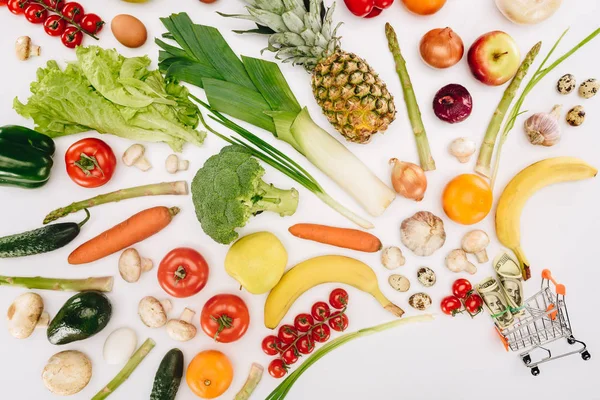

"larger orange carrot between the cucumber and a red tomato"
[69,207,179,265]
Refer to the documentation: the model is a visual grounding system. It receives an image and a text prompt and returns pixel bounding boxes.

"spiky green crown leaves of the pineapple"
[219,0,341,72]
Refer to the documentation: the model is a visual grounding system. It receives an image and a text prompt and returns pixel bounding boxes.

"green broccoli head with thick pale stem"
[192,145,298,244]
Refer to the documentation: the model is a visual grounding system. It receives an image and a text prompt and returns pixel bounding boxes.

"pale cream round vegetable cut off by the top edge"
[496,0,562,25]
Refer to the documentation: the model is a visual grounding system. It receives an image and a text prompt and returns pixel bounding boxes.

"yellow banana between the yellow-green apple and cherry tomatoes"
[265,256,404,329]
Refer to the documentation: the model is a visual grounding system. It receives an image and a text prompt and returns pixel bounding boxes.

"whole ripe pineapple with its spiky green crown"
[226,0,396,143]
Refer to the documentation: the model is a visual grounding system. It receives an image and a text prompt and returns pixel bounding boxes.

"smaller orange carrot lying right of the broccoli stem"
[289,224,381,253]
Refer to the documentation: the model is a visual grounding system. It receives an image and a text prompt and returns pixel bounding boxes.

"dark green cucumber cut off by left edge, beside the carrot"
[0,210,90,258]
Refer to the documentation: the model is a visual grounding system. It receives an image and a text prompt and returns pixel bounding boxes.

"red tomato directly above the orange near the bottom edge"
[200,294,250,343]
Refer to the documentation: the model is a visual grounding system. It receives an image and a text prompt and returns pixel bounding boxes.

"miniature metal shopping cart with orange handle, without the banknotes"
[496,269,591,376]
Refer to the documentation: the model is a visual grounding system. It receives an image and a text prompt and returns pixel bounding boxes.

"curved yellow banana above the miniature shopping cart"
[496,157,598,279]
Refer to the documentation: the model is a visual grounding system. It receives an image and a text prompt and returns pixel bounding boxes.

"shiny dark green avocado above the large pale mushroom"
[46,292,112,344]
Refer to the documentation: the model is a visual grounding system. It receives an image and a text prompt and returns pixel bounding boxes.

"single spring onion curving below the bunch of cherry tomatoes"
[265,314,433,400]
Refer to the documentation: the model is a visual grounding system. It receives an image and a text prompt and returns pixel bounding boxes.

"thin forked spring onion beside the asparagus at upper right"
[491,28,600,188]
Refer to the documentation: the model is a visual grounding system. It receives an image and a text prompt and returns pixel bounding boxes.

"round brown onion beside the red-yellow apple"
[419,28,465,68]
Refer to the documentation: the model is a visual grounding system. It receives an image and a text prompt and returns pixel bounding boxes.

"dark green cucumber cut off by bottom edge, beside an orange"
[150,349,183,400]
